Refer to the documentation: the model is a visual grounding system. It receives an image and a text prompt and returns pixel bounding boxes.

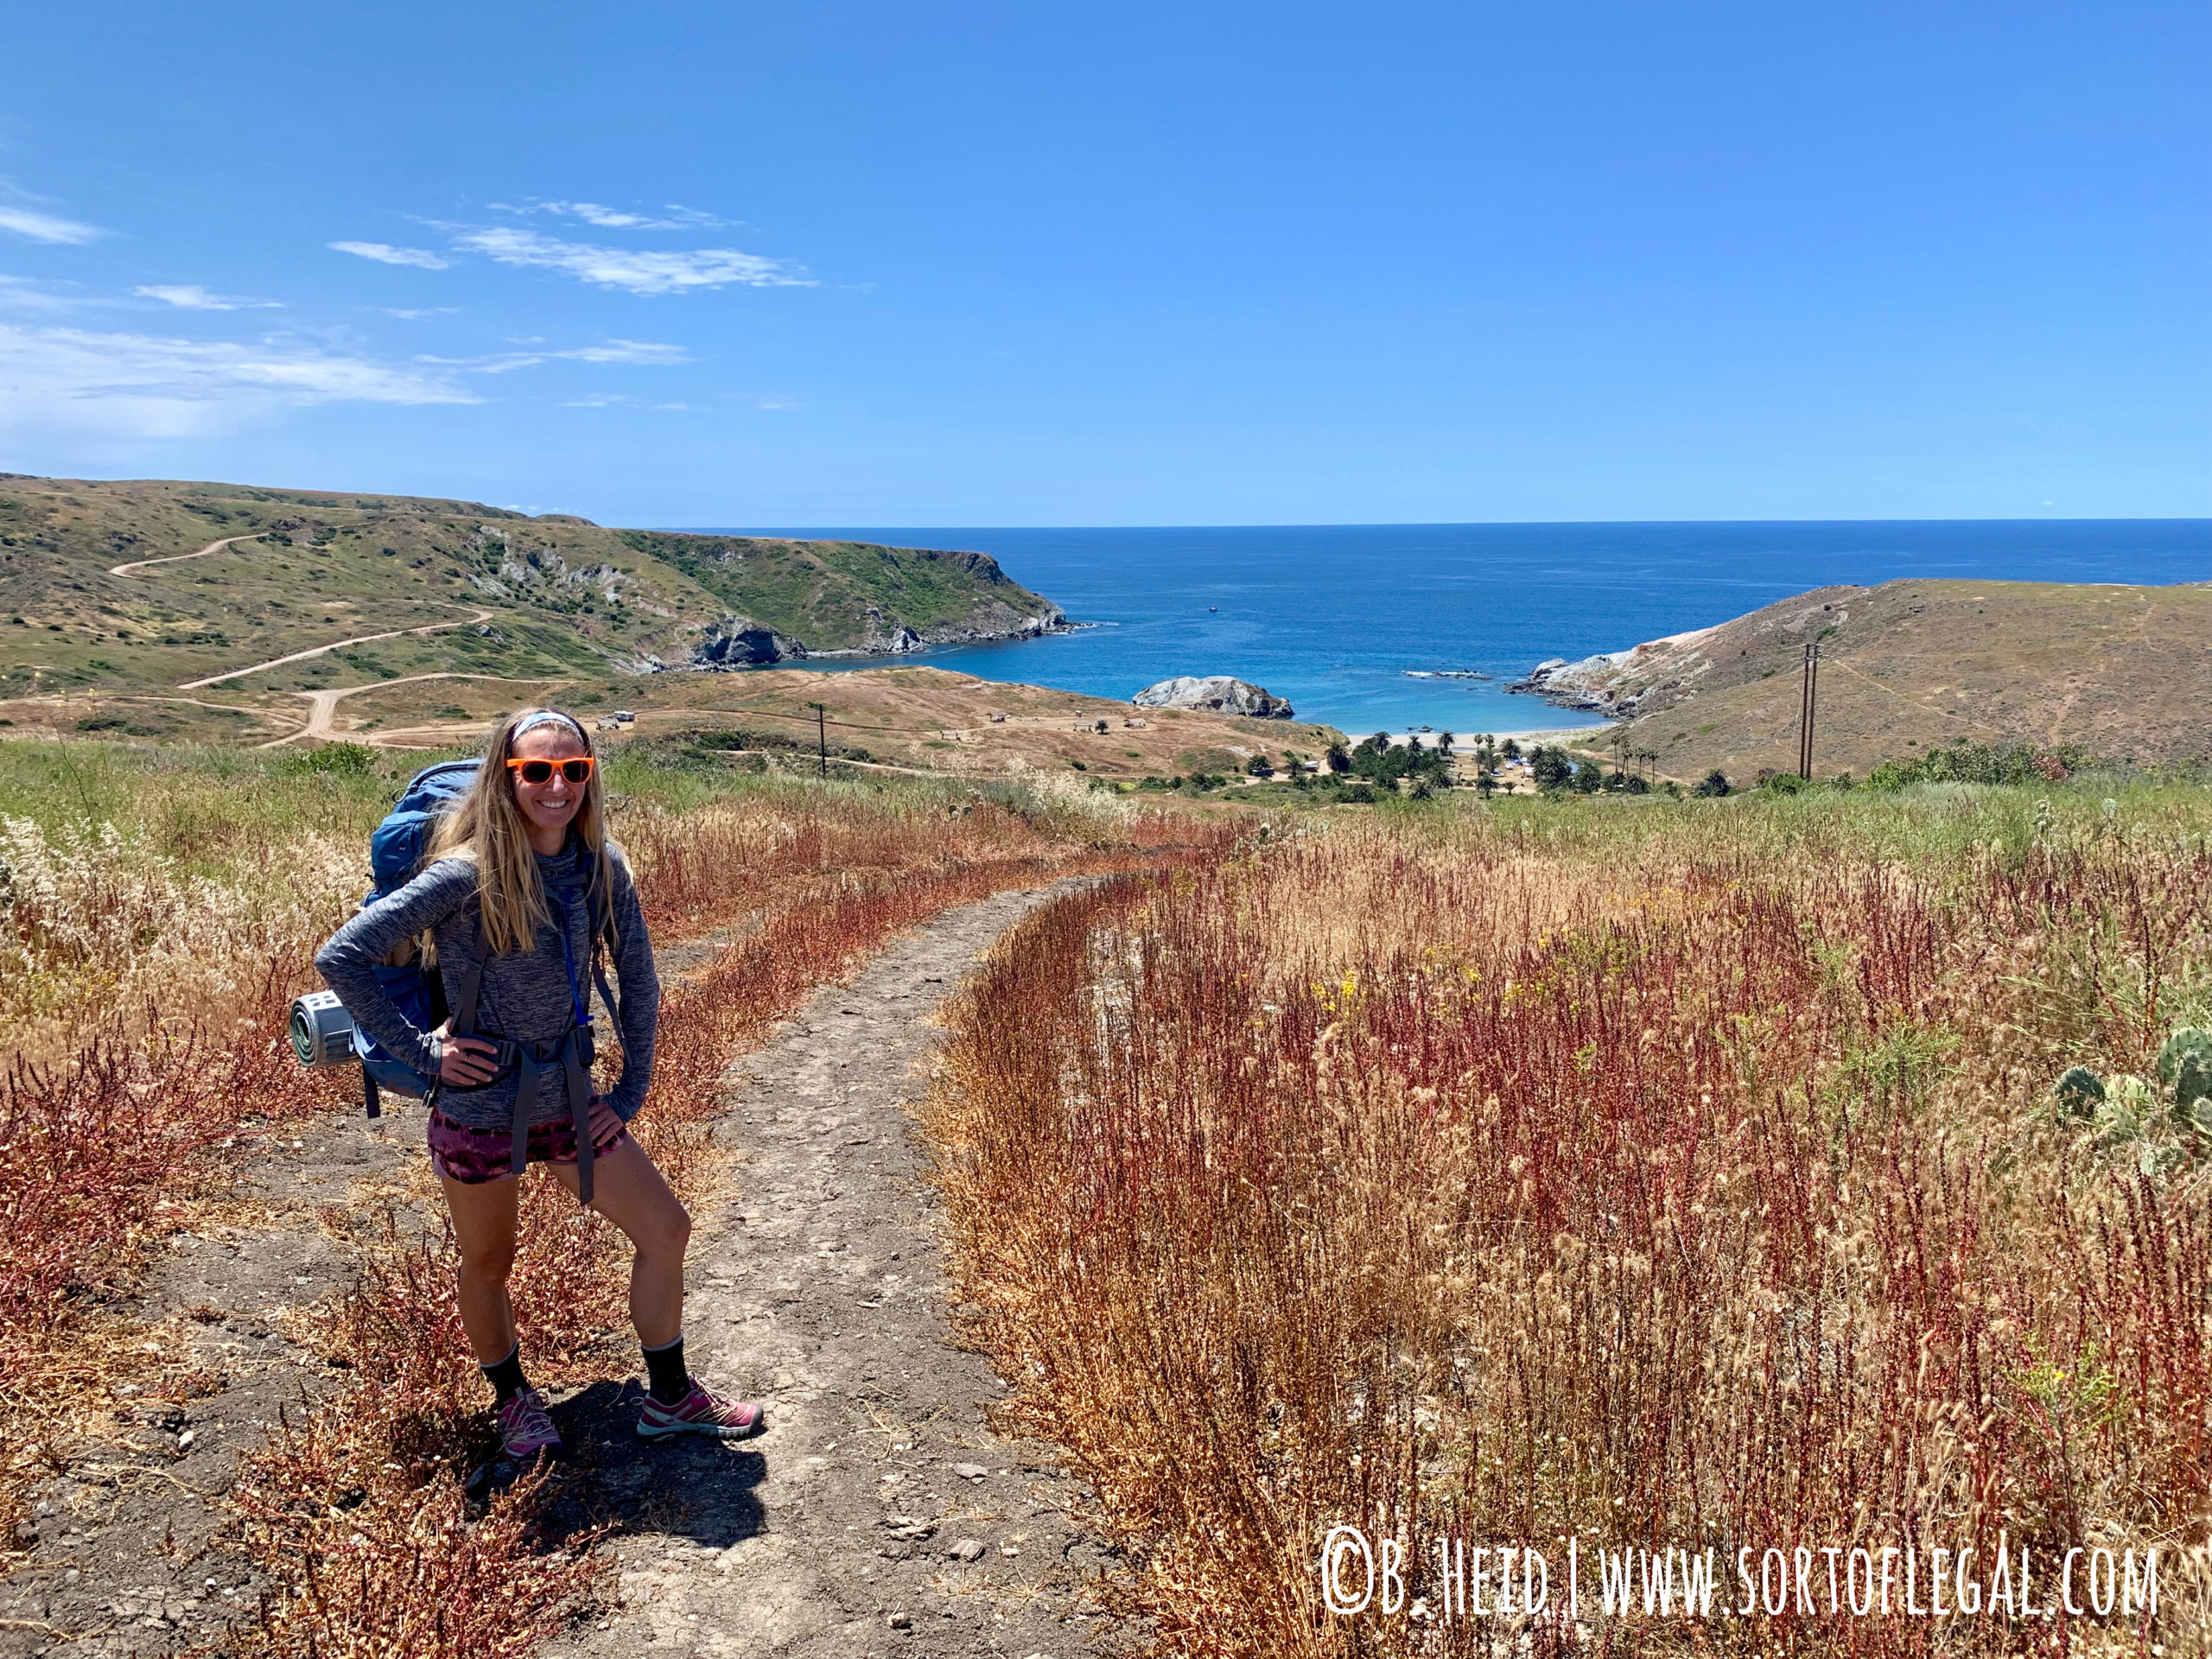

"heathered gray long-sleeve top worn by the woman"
[315,838,661,1128]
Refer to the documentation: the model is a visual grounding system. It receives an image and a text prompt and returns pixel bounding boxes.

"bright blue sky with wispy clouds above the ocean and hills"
[0,0,2212,526]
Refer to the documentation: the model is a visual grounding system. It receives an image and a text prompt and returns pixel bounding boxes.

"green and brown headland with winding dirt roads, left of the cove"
[0,474,1066,716]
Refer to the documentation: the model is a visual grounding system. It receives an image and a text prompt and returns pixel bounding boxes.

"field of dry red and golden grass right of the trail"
[929,834,2212,1659]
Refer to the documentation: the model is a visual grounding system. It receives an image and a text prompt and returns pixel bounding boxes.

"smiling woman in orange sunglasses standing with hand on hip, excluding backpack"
[315,708,763,1462]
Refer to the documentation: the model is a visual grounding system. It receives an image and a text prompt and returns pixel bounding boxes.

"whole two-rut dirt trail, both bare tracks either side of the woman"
[0,893,1110,1659]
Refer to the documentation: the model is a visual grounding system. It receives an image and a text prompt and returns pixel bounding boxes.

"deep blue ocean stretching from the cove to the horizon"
[694,520,2212,734]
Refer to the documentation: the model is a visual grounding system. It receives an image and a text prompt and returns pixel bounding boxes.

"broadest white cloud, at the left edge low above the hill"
[0,323,482,438]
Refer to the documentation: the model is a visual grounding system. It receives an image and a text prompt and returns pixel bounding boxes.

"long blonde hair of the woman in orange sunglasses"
[429,708,615,956]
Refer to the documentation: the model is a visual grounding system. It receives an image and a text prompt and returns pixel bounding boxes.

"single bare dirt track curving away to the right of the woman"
[550,893,1109,1659]
